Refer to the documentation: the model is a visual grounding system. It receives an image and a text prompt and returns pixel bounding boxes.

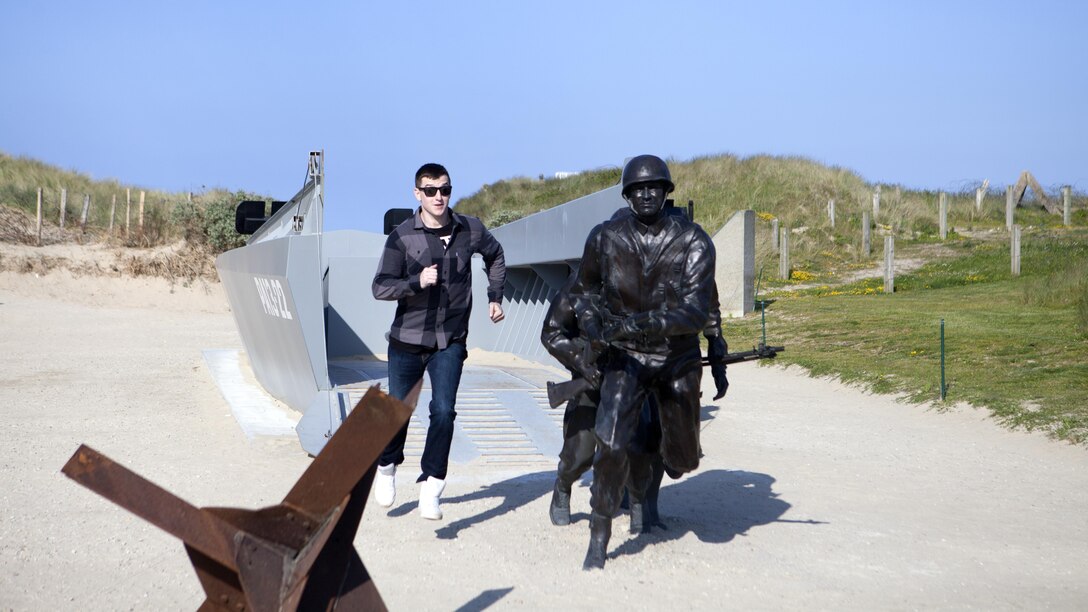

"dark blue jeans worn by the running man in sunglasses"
[378,342,468,482]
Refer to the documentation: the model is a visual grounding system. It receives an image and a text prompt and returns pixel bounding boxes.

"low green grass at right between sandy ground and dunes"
[727,230,1088,443]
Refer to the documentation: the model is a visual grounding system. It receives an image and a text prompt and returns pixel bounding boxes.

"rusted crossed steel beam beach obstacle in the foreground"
[62,381,422,612]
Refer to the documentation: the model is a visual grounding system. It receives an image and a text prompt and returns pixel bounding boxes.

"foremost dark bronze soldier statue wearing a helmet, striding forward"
[571,155,714,570]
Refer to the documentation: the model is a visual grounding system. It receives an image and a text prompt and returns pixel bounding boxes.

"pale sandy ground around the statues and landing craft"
[0,263,1088,610]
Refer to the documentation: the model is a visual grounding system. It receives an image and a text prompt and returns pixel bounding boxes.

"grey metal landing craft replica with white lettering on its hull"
[215,151,755,455]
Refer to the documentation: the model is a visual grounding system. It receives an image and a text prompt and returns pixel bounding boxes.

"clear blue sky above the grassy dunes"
[0,0,1088,231]
